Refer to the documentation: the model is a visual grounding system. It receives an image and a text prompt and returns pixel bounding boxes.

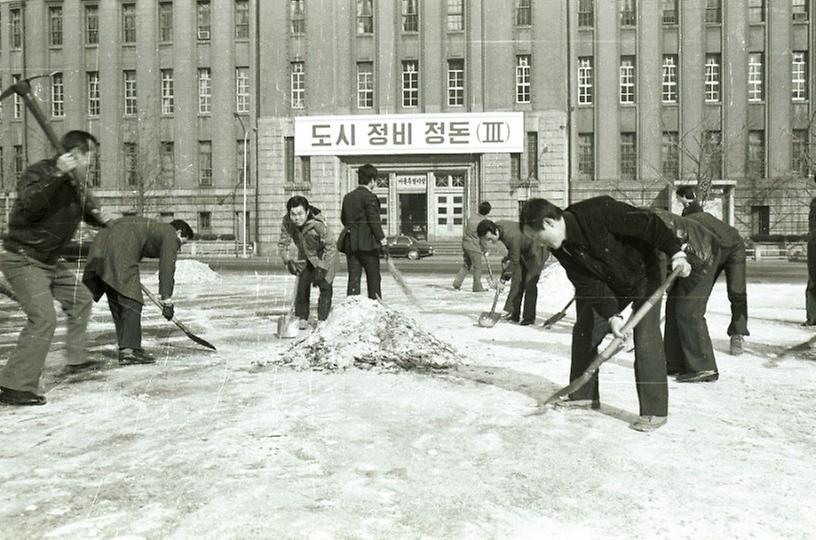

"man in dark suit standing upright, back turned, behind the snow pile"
[340,164,386,300]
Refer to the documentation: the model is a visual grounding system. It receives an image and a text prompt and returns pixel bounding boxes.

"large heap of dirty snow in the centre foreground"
[282,296,461,370]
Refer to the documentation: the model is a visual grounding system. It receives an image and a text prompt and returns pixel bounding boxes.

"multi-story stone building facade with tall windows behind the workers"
[0,0,816,253]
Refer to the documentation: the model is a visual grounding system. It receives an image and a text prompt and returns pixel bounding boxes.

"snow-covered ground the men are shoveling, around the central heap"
[0,263,816,539]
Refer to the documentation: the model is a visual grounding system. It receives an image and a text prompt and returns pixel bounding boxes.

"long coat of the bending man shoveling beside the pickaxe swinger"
[82,216,181,304]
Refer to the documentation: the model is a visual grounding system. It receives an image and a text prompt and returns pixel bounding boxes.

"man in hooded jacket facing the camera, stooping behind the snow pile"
[278,195,337,328]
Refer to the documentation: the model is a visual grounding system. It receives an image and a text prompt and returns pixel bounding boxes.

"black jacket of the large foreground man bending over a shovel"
[552,196,681,319]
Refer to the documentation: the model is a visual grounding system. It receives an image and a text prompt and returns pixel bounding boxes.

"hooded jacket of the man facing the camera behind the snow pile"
[278,207,337,283]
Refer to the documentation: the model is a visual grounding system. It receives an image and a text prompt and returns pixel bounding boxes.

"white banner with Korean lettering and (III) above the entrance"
[295,112,524,156]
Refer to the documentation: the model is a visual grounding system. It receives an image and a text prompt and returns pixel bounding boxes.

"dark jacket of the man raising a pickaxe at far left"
[3,158,104,264]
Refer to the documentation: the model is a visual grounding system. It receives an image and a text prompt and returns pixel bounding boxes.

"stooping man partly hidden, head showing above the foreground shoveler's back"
[676,186,752,356]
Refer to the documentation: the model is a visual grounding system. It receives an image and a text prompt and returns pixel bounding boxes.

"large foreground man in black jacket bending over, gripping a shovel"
[522,197,691,431]
